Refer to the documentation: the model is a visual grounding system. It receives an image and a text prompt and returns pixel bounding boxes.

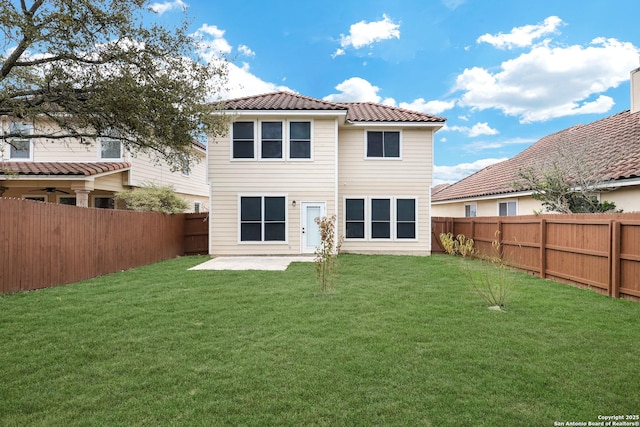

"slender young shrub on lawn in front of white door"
[314,215,342,292]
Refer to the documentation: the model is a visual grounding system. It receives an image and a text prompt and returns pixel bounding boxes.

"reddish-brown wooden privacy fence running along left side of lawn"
[0,198,185,293]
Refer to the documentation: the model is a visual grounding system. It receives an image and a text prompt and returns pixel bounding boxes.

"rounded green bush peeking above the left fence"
[114,185,189,214]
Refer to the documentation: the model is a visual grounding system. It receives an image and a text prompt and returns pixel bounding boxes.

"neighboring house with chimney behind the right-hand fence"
[431,68,640,217]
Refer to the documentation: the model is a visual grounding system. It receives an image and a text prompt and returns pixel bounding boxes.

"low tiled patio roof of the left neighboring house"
[0,162,131,176]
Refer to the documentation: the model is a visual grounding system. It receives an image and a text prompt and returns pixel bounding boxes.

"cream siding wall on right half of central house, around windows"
[338,127,433,255]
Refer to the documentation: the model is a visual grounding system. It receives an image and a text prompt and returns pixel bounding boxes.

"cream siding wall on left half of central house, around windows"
[208,116,337,255]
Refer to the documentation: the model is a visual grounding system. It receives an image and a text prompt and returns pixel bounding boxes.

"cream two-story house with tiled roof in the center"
[208,92,445,255]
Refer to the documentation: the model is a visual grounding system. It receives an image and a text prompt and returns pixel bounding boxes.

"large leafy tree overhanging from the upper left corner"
[0,0,226,171]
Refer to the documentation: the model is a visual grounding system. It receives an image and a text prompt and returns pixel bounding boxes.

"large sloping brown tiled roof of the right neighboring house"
[432,111,640,202]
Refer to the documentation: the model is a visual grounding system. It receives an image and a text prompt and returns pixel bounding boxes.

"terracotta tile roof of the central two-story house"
[224,92,446,123]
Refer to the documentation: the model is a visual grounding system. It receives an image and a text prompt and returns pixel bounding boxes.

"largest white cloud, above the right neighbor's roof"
[454,38,638,123]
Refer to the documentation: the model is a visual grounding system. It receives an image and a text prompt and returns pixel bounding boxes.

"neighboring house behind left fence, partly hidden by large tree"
[0,117,209,211]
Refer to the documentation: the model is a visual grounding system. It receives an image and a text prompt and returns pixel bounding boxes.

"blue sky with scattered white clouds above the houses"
[152,0,640,184]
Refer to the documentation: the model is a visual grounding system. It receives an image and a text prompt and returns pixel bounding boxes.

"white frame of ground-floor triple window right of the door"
[342,195,420,242]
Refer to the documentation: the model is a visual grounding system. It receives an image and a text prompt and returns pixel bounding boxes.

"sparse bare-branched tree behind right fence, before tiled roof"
[513,141,617,213]
